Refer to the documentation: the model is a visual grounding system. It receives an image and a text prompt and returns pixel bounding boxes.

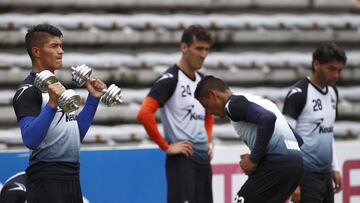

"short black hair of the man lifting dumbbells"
[25,24,63,60]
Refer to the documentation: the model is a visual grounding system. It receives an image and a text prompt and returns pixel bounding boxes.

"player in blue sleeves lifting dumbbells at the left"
[13,24,106,203]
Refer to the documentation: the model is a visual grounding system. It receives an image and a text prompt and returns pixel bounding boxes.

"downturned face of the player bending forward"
[199,90,225,117]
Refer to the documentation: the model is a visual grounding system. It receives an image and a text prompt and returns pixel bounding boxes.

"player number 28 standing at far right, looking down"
[283,43,346,203]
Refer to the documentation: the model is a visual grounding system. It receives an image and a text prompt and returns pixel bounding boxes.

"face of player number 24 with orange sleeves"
[181,37,210,70]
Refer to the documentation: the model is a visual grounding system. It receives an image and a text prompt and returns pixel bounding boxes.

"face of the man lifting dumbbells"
[37,36,64,71]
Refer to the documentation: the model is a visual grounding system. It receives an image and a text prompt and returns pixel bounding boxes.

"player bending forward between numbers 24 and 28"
[195,76,303,203]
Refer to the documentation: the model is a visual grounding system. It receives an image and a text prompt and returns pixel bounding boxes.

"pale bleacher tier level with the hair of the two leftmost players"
[0,13,360,45]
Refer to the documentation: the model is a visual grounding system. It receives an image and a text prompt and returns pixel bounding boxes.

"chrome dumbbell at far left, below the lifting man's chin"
[34,70,81,113]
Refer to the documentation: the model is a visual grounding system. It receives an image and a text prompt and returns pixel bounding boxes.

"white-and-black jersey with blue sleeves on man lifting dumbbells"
[13,72,99,164]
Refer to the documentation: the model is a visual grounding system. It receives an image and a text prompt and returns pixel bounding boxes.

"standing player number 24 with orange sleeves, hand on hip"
[138,25,214,203]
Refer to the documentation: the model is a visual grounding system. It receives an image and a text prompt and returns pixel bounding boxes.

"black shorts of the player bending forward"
[234,167,303,203]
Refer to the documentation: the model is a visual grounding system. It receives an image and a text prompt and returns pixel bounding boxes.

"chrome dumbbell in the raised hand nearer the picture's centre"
[71,64,123,106]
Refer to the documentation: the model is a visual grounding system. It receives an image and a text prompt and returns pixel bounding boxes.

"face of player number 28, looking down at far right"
[315,60,344,86]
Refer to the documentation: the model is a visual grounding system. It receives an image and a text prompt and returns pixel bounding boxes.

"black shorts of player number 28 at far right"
[300,172,334,203]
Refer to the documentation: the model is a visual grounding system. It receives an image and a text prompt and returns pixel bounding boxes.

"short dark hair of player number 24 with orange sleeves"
[181,25,212,46]
